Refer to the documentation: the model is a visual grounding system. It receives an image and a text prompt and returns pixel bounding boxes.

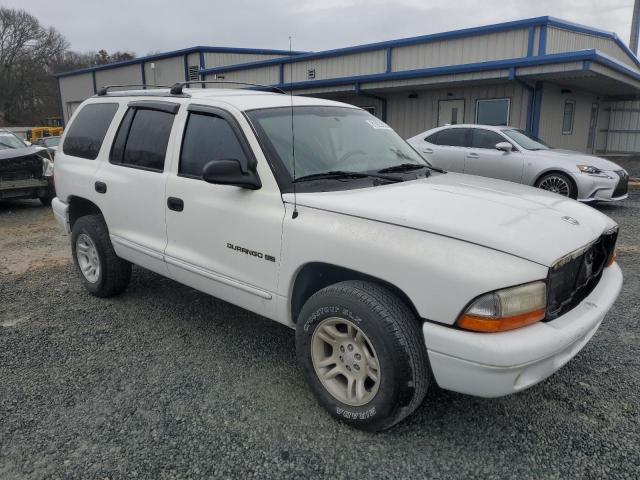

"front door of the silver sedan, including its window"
[464,128,524,183]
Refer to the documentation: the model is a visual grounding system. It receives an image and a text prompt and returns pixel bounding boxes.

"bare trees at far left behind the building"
[0,7,135,126]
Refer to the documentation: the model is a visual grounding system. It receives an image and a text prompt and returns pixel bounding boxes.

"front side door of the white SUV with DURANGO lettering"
[165,105,285,317]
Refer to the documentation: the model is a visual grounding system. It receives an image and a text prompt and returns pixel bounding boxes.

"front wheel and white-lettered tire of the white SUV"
[296,281,429,431]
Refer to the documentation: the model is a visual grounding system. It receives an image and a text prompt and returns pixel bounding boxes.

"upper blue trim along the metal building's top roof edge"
[202,16,640,75]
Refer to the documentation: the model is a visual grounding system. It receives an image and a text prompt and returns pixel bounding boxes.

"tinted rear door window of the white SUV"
[110,108,174,172]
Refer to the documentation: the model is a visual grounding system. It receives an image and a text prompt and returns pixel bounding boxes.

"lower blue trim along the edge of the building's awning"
[264,49,640,90]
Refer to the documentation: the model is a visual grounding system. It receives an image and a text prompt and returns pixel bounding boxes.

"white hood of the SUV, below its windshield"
[284,173,616,266]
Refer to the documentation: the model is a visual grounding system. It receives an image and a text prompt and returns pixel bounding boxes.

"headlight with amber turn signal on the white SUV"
[457,281,547,332]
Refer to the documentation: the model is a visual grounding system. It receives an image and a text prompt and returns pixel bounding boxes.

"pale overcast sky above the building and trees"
[0,0,633,56]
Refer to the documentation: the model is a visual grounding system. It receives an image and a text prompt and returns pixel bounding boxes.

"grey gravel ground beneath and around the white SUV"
[0,196,640,479]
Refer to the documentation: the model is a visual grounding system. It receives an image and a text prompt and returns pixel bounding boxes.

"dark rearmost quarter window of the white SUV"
[62,103,118,160]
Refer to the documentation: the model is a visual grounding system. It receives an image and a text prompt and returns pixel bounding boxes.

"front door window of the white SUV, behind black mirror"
[178,113,247,177]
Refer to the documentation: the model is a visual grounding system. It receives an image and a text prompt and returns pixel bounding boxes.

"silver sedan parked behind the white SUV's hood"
[407,125,629,202]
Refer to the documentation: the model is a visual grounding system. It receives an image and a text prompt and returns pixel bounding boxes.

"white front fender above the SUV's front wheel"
[278,205,547,325]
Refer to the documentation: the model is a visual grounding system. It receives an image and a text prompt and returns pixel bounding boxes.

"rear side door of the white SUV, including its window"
[95,100,180,274]
